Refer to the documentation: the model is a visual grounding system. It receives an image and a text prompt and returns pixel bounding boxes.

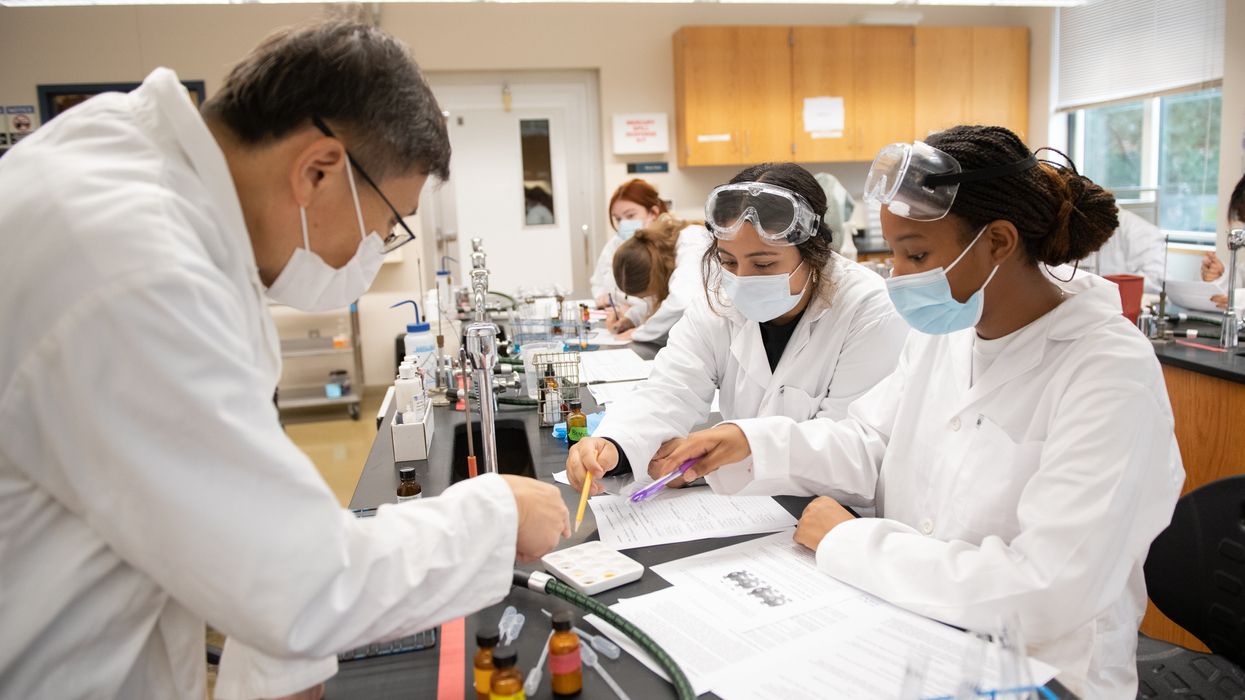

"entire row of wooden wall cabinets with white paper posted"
[674,26,1028,167]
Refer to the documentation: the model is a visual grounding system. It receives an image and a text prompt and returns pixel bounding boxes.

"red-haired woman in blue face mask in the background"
[589,178,667,321]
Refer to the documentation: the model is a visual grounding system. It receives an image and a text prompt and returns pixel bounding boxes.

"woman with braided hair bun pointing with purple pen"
[657,126,1184,698]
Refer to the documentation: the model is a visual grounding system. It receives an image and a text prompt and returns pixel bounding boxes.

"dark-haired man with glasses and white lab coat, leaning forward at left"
[0,21,568,699]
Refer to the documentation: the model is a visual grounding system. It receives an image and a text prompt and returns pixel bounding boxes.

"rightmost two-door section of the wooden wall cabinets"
[915,26,1028,138]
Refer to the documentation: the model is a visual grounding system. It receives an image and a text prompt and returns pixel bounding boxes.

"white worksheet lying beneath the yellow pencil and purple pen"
[588,488,796,549]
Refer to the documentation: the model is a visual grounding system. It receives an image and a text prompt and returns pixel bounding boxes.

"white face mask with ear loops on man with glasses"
[268,161,385,313]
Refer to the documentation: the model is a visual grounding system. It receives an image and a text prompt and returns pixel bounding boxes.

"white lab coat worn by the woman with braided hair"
[716,267,1184,699]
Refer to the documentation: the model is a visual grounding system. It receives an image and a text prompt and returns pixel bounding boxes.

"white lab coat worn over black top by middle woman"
[595,254,908,478]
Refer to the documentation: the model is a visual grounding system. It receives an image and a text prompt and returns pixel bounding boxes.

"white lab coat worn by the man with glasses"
[0,69,517,700]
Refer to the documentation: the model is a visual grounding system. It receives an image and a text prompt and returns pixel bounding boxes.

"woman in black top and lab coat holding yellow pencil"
[566,163,908,491]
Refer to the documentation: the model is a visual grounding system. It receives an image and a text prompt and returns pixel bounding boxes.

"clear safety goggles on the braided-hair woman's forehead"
[864,141,1037,222]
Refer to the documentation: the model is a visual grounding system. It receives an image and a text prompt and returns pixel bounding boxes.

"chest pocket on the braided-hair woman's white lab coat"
[952,416,1042,542]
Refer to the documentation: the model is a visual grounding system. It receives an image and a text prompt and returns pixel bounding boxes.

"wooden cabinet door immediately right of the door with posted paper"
[850,26,916,161]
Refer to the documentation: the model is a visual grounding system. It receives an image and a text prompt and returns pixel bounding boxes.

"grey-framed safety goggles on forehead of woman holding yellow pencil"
[705,182,820,245]
